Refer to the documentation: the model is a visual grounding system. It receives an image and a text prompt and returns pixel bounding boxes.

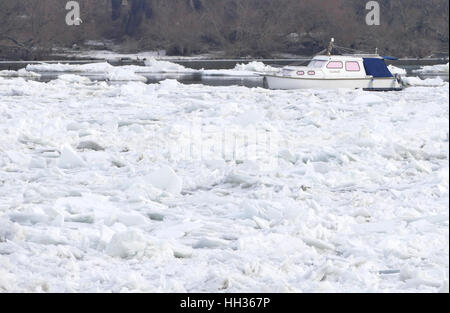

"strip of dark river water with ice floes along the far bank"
[0,58,449,88]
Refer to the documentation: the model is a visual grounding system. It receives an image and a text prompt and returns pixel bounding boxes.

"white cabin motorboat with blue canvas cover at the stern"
[264,40,403,91]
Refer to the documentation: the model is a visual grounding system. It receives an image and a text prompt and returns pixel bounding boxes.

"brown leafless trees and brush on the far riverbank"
[0,0,449,58]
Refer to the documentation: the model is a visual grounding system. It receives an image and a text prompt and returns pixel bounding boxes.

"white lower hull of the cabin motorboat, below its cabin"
[264,75,403,91]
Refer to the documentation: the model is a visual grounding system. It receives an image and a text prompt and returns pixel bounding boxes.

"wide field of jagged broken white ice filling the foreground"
[0,65,449,292]
